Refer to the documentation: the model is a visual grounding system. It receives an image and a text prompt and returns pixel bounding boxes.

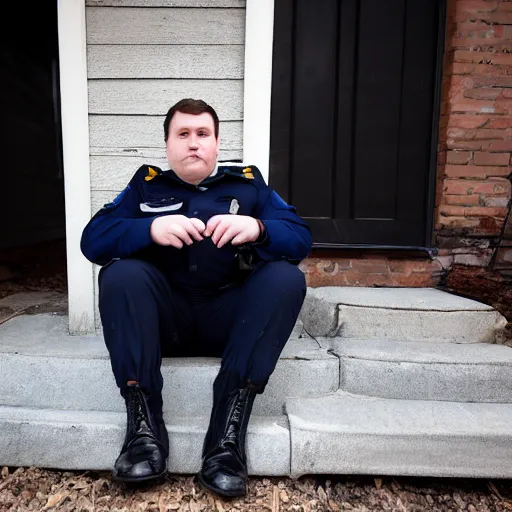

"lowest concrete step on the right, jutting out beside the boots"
[286,392,512,478]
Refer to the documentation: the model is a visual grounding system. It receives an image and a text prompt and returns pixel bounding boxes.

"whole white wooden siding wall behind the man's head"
[86,0,245,208]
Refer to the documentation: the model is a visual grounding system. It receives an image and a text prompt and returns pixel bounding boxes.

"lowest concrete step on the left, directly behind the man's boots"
[0,406,290,475]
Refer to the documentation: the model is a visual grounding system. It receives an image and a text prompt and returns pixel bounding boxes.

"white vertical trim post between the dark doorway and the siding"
[57,0,94,334]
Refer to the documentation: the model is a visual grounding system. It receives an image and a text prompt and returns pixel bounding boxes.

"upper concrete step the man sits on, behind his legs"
[0,315,339,416]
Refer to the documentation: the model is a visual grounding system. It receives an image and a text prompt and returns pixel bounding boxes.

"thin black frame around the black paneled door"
[269,0,447,253]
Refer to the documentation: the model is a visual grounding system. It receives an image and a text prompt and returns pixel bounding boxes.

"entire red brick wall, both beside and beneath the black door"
[301,0,512,286]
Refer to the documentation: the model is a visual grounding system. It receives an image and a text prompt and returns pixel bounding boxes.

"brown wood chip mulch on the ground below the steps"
[0,467,512,512]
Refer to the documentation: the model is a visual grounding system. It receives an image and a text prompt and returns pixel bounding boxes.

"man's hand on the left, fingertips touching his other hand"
[150,215,205,249]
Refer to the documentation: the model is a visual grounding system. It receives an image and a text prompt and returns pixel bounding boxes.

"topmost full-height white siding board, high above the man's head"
[87,7,245,45]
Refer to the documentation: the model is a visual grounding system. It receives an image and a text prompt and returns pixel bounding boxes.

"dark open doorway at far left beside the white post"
[0,1,66,308]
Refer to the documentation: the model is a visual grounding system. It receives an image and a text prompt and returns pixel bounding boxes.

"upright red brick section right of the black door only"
[436,0,512,266]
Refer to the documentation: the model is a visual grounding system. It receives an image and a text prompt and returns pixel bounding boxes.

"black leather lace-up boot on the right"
[199,388,256,497]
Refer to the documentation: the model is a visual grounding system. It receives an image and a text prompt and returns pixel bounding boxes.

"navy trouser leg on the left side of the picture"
[99,259,192,411]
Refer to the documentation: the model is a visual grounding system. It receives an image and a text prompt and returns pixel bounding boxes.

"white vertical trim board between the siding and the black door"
[243,0,274,182]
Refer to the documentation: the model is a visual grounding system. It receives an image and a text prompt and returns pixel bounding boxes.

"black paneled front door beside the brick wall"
[270,0,444,247]
